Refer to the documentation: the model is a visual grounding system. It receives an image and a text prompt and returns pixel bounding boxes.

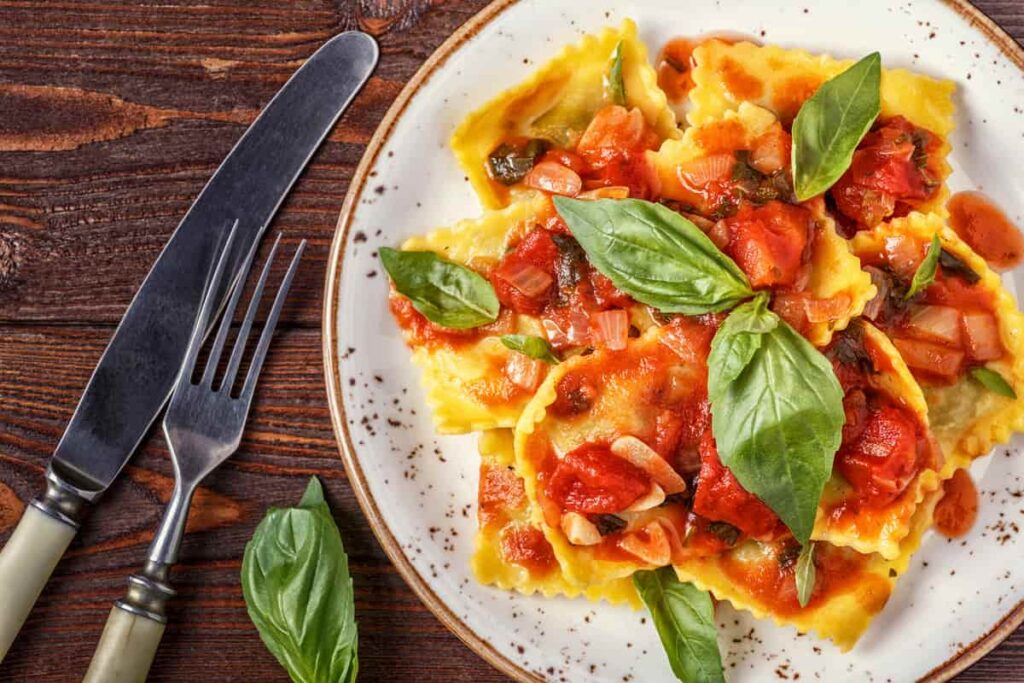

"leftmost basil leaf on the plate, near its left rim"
[380,247,501,330]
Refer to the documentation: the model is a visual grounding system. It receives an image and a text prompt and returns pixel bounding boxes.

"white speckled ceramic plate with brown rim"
[324,0,1024,683]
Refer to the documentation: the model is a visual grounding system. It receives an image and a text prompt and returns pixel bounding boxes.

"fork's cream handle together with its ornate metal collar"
[83,562,174,683]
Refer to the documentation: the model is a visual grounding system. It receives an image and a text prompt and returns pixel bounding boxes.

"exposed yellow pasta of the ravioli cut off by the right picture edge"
[851,213,1024,479]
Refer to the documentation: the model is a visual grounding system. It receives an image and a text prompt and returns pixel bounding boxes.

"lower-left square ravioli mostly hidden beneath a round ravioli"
[470,429,640,607]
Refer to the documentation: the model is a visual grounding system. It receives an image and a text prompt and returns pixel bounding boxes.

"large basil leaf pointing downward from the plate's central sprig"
[708,309,846,545]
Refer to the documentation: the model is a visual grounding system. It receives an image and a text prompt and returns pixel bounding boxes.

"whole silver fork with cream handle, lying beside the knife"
[84,228,306,683]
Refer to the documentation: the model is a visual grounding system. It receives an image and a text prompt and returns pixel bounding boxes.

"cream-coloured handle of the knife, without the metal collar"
[0,505,78,660]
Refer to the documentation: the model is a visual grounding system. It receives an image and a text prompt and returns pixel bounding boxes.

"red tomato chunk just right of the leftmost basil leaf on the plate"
[490,229,558,315]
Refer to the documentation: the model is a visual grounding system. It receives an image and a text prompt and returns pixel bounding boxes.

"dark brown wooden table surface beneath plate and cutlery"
[0,0,1024,683]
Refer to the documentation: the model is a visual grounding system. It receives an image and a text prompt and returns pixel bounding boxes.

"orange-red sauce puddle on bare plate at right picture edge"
[947,191,1024,270]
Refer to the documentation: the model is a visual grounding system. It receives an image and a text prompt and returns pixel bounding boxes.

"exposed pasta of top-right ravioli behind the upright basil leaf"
[687,40,955,212]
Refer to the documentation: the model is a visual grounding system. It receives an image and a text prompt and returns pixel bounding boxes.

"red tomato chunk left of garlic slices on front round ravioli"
[545,443,650,514]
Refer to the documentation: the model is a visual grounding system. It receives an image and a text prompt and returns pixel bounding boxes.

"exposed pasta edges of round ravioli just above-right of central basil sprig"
[649,102,876,346]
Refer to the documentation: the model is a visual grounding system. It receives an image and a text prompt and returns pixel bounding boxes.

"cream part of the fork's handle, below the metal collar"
[82,604,165,683]
